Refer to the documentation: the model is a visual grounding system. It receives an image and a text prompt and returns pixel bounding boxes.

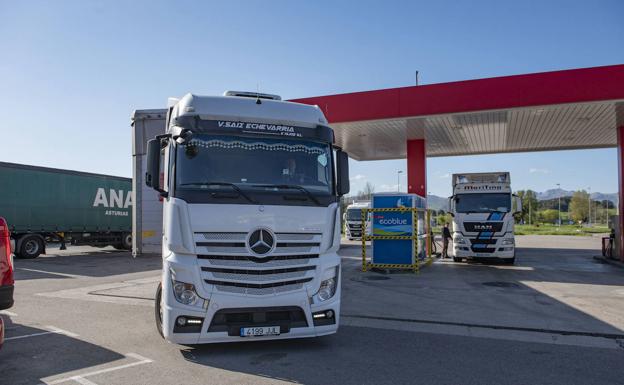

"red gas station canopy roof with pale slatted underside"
[293,65,624,160]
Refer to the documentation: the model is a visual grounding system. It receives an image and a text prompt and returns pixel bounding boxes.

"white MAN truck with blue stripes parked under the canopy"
[449,172,522,264]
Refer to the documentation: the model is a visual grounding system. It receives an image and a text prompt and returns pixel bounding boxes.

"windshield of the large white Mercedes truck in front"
[176,134,332,195]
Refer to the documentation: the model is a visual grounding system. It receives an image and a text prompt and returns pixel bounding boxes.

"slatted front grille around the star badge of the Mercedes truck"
[195,233,321,295]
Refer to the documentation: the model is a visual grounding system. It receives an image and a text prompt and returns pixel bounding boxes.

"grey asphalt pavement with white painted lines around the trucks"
[0,237,624,385]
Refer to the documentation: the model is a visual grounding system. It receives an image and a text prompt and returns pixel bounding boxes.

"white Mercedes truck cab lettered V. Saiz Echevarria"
[145,92,349,344]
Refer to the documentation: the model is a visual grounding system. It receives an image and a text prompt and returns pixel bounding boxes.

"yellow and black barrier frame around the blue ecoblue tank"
[361,207,433,273]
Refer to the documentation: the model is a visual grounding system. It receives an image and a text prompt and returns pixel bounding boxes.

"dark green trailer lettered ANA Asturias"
[0,162,132,258]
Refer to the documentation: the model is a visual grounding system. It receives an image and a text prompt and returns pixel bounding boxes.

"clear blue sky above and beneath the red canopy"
[0,0,624,195]
